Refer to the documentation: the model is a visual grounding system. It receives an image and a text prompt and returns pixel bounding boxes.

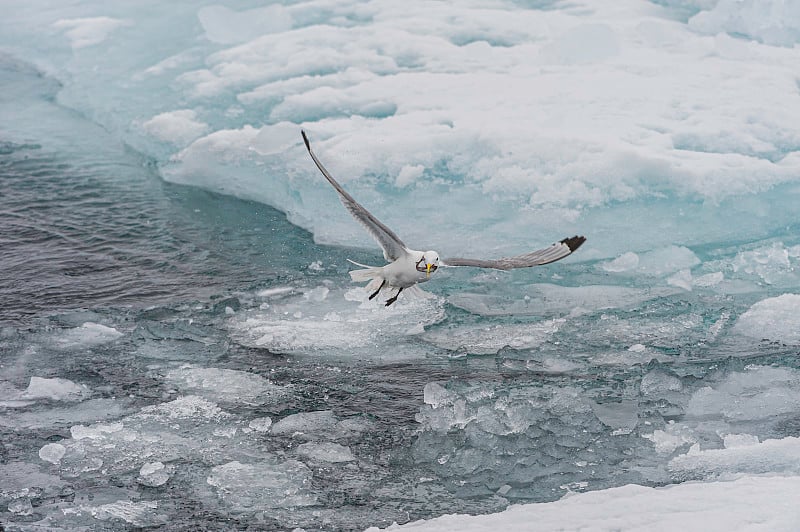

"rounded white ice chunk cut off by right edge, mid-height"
[733,294,800,345]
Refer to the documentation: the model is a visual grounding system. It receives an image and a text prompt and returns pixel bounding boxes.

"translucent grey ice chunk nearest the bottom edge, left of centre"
[206,460,316,512]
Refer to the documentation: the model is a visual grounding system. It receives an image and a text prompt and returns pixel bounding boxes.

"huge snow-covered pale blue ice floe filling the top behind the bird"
[0,0,800,258]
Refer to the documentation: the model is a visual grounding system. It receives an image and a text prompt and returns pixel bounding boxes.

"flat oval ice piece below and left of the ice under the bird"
[166,367,288,405]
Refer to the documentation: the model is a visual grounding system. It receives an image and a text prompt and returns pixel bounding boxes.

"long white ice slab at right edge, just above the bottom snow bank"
[669,436,800,480]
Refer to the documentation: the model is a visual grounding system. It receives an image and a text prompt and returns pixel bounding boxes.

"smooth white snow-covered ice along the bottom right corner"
[368,476,800,532]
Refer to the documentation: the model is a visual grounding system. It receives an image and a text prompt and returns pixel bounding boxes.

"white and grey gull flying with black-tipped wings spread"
[300,130,586,307]
